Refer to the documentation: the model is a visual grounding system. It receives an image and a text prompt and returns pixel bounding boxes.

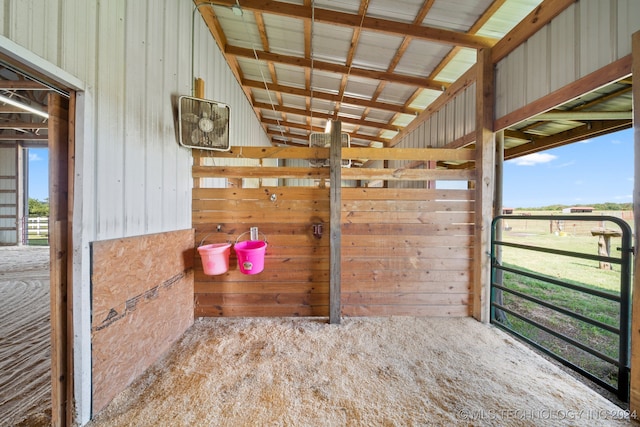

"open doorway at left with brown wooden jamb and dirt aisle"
[0,54,75,425]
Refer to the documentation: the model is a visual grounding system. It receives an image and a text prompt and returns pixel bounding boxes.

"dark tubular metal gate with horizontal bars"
[491,215,633,402]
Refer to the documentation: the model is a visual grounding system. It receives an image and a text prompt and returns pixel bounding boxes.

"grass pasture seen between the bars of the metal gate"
[492,212,632,396]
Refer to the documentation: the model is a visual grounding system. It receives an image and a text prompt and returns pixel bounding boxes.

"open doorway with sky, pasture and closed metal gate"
[491,125,635,406]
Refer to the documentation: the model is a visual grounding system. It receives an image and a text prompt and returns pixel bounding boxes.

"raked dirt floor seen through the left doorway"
[0,246,51,426]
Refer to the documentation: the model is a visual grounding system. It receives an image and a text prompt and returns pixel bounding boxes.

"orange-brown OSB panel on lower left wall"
[91,230,194,413]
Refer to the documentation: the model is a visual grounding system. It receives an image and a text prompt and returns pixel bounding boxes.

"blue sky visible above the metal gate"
[503,129,633,208]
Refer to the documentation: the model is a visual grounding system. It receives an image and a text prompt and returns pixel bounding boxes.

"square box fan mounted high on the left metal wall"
[178,96,231,151]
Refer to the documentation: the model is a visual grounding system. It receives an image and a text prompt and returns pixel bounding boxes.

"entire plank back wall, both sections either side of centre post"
[193,147,475,316]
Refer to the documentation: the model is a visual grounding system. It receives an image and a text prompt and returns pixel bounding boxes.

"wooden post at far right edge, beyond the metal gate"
[629,31,640,413]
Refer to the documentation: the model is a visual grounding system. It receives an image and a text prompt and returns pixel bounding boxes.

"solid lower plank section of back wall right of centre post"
[342,188,474,316]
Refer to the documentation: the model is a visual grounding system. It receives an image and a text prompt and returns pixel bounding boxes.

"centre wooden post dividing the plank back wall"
[329,121,342,324]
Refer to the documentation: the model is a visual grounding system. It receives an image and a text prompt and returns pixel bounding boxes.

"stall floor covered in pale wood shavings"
[90,317,630,427]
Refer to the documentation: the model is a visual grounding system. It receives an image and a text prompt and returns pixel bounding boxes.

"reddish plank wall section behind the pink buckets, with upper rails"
[192,147,329,316]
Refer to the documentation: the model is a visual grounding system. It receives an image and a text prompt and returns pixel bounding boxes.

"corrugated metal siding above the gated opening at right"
[496,0,640,118]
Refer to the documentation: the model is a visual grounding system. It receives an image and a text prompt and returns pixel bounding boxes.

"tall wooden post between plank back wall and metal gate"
[472,49,496,322]
